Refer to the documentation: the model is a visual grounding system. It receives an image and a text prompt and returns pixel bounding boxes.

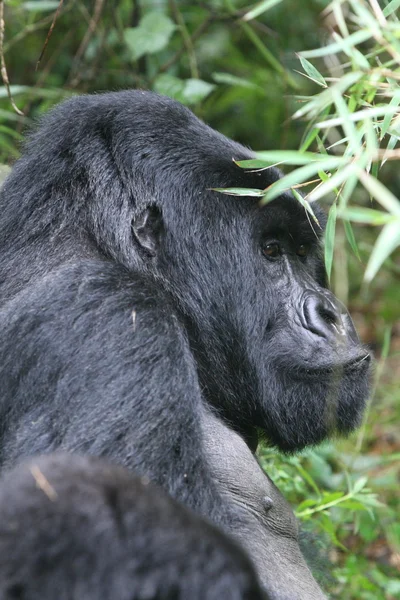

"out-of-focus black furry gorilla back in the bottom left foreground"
[0,454,265,600]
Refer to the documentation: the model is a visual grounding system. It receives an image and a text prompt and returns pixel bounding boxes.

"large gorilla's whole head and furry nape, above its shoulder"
[2,92,370,451]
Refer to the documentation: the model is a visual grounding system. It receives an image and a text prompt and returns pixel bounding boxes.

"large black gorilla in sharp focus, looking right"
[0,91,370,600]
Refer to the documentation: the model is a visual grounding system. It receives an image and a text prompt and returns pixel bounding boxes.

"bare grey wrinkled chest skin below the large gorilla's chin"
[202,411,326,600]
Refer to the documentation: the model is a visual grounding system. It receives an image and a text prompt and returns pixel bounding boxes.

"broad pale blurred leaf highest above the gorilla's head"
[124,12,176,60]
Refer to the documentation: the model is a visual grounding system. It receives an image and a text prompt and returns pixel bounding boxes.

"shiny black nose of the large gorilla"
[301,290,359,343]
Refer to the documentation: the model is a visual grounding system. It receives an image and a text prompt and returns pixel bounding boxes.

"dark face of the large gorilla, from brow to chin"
[161,180,370,451]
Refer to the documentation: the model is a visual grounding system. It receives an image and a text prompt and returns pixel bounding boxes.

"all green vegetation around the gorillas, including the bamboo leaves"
[0,0,400,600]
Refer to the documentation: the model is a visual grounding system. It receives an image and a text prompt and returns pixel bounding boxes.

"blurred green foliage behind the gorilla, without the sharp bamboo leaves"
[0,0,400,600]
